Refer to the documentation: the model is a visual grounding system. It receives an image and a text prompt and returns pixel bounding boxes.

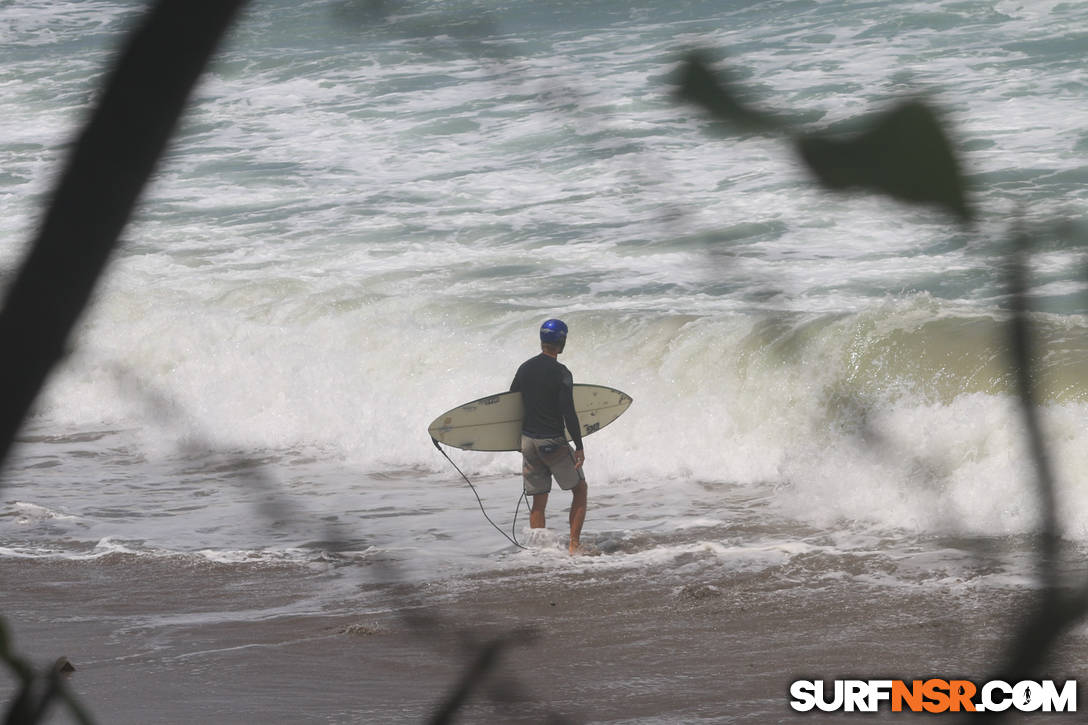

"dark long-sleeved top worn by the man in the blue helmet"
[510,353,582,451]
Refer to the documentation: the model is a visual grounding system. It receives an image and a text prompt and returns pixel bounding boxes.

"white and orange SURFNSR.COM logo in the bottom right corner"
[790,678,1077,713]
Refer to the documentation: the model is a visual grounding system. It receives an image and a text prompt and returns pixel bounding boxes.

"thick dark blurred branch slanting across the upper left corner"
[0,0,245,466]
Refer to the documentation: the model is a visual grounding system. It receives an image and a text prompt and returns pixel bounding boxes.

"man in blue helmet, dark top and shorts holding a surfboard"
[510,320,589,554]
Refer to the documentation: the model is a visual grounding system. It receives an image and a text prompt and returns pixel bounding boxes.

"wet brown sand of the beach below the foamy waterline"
[0,555,1086,724]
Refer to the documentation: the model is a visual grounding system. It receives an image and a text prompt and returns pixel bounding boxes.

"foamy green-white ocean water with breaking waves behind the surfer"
[0,0,1088,640]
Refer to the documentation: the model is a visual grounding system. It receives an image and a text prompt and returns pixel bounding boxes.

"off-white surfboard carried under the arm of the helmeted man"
[426,383,631,451]
